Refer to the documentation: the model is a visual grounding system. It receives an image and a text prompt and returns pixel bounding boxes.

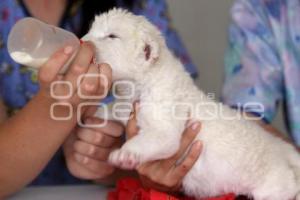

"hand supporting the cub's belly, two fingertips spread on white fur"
[126,105,202,192]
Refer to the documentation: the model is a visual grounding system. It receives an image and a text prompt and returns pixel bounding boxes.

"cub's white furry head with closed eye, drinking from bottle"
[83,9,165,80]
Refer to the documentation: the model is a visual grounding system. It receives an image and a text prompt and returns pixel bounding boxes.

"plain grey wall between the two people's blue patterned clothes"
[167,0,286,133]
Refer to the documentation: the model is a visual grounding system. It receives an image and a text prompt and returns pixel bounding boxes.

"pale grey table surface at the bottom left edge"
[8,185,109,200]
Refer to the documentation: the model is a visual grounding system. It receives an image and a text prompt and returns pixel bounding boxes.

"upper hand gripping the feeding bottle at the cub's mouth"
[38,42,112,113]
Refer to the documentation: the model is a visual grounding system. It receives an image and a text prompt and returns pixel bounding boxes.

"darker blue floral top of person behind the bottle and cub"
[0,0,197,185]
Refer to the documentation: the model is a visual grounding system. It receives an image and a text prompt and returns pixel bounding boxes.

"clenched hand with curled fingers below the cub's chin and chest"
[63,117,124,180]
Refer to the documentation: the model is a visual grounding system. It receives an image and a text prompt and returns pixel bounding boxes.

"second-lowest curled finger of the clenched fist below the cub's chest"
[74,140,110,161]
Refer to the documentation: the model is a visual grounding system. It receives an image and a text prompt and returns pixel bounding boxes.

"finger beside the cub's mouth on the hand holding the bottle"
[65,42,94,92]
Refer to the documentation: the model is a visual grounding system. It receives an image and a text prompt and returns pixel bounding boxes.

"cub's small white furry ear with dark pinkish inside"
[138,33,160,65]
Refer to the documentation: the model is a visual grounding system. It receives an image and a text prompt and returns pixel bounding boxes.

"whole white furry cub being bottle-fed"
[85,9,300,200]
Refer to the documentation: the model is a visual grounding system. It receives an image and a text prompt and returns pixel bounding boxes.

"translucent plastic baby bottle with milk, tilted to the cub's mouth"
[7,17,80,74]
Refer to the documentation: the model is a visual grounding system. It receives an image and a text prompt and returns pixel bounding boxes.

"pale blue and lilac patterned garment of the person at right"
[223,0,300,145]
